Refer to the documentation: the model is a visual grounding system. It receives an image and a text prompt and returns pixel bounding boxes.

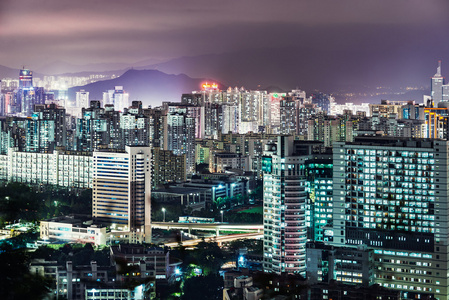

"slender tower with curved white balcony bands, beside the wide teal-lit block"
[262,136,309,276]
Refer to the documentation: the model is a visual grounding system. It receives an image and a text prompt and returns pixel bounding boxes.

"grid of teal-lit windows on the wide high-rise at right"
[345,149,438,233]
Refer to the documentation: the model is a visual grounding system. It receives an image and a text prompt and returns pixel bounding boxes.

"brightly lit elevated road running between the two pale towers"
[151,222,263,232]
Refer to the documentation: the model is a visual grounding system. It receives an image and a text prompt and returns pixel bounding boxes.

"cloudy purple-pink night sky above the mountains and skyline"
[0,0,449,92]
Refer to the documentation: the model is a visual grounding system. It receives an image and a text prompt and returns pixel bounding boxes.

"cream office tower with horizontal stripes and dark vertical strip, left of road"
[92,146,151,243]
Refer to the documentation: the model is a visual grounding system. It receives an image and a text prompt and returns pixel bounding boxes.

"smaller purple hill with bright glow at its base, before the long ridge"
[69,69,223,106]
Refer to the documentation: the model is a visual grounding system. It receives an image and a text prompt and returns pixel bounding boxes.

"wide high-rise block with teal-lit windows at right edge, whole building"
[329,137,449,299]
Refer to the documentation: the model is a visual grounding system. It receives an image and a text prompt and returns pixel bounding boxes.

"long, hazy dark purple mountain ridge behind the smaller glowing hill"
[143,46,436,101]
